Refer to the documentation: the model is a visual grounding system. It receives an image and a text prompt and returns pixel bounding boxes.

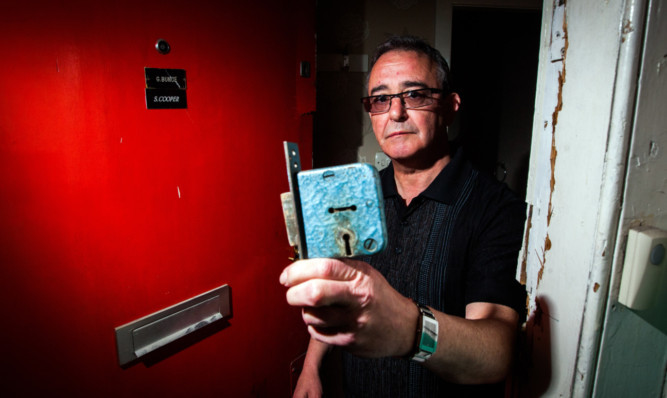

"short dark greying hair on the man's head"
[366,36,451,93]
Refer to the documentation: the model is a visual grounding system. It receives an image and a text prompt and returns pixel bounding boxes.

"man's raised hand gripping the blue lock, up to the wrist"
[280,258,419,357]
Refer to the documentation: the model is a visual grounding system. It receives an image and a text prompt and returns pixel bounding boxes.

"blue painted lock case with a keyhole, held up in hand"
[297,163,387,258]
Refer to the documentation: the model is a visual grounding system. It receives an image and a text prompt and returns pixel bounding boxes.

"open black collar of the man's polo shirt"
[380,150,471,205]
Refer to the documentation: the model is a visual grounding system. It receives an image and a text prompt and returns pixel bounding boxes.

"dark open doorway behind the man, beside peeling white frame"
[451,7,542,197]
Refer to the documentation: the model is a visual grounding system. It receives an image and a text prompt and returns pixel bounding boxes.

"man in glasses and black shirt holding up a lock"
[280,37,525,397]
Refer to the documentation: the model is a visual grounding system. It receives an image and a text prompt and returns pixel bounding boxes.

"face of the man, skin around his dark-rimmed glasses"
[368,50,446,165]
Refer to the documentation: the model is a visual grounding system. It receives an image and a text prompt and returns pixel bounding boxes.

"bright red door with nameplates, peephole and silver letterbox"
[0,0,315,397]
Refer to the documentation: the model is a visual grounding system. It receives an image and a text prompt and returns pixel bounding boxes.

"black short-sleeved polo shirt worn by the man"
[343,151,526,397]
